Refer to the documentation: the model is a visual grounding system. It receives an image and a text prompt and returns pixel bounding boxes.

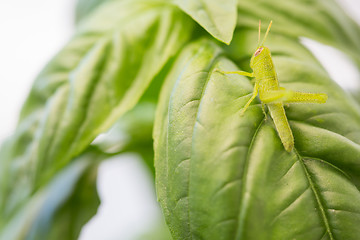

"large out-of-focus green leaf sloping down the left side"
[0,0,193,227]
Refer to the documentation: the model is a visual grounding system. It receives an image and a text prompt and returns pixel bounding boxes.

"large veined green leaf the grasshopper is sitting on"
[154,29,360,240]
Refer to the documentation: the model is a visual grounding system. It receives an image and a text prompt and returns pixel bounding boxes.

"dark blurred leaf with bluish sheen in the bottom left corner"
[0,152,102,240]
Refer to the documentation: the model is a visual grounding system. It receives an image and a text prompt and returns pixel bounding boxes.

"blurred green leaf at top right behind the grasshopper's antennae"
[238,0,360,67]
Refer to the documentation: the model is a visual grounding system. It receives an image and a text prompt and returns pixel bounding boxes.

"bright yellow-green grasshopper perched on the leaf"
[218,21,328,152]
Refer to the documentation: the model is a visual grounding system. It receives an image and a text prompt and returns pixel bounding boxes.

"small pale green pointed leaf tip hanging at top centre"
[173,0,237,44]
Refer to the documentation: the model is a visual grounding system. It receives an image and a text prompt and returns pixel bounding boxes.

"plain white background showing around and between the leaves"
[0,0,360,240]
